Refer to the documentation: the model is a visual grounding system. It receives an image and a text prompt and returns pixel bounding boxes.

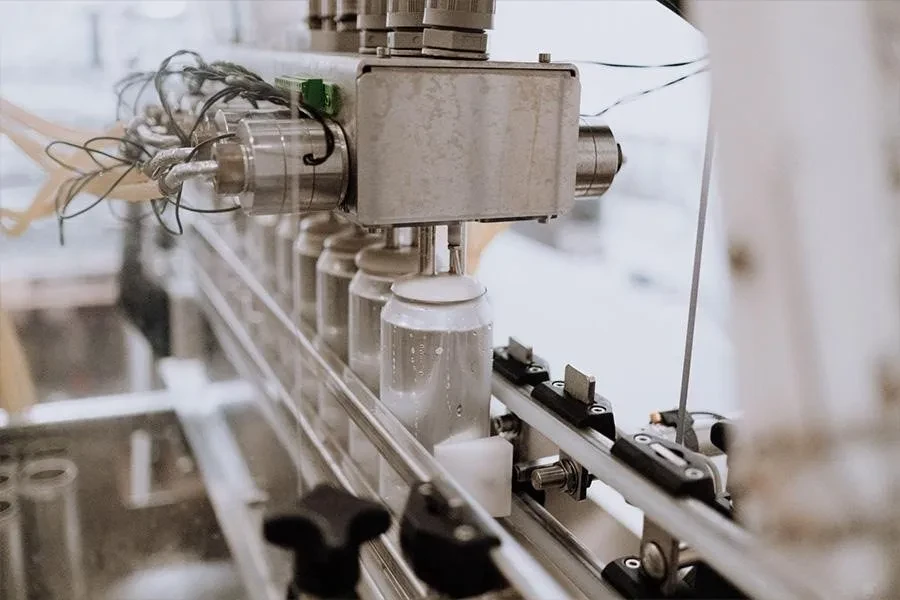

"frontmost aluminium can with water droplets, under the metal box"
[380,275,493,452]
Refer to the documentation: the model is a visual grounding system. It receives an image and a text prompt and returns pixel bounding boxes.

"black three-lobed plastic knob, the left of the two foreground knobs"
[263,485,391,600]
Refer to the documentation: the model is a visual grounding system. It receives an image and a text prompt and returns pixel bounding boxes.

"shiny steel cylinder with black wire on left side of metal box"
[225,119,350,215]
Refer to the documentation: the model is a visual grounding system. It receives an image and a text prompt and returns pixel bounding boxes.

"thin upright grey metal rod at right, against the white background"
[675,109,715,444]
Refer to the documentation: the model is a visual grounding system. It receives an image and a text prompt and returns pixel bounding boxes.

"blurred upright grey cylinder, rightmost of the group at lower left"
[18,458,87,600]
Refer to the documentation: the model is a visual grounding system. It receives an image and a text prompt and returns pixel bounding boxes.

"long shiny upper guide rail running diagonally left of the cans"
[192,220,567,600]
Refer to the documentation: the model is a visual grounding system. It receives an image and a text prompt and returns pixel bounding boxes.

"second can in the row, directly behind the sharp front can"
[348,232,419,485]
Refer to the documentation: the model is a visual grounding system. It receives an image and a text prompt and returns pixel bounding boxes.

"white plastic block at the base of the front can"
[434,436,513,517]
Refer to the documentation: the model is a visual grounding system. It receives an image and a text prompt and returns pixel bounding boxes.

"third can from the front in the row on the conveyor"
[316,227,379,447]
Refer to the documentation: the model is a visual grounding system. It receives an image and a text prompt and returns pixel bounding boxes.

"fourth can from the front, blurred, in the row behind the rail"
[287,212,350,407]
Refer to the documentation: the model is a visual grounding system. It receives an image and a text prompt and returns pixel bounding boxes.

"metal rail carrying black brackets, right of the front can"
[491,375,825,600]
